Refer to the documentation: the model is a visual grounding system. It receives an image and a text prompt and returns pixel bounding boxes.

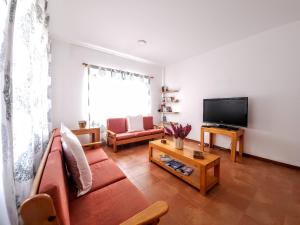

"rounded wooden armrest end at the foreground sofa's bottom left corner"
[20,194,59,225]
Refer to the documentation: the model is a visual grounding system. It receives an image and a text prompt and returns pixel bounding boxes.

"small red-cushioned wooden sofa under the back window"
[107,116,164,152]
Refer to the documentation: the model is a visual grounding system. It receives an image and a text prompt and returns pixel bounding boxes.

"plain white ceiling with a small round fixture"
[49,0,300,65]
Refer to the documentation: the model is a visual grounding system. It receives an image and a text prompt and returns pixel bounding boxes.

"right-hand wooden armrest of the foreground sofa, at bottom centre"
[120,201,169,225]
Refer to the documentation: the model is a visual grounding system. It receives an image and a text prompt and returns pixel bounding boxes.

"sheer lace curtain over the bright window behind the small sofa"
[88,67,151,139]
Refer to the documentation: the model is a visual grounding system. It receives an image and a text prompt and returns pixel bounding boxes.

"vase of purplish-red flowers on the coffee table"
[165,123,192,150]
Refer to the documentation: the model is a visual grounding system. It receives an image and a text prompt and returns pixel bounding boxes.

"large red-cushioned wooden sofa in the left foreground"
[21,130,168,225]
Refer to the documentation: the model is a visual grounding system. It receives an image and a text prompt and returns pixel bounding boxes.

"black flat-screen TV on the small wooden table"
[203,97,248,127]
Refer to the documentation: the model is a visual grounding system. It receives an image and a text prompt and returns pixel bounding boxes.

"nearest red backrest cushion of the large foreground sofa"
[38,151,70,225]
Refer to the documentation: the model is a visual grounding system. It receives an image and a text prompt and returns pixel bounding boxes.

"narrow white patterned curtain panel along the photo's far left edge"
[0,0,18,225]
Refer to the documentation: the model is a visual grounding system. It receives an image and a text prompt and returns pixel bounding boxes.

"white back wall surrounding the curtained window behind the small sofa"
[50,40,162,128]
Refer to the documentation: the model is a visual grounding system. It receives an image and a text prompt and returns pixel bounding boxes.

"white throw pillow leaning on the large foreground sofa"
[60,124,92,196]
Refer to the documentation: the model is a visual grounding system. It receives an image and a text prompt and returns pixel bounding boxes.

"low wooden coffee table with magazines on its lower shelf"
[149,140,220,194]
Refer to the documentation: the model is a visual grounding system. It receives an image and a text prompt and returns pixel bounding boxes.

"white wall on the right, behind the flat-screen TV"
[165,21,300,166]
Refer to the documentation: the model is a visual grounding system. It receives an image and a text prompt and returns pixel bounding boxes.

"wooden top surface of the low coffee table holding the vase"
[149,139,220,166]
